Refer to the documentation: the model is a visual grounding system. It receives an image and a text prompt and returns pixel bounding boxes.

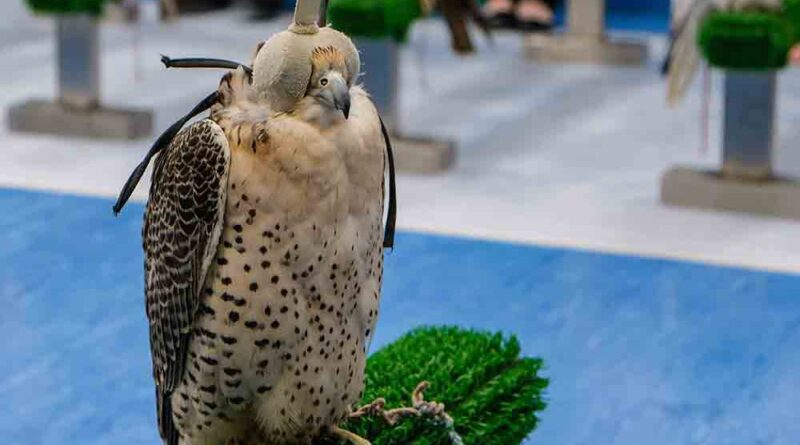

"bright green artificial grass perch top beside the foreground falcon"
[318,327,548,445]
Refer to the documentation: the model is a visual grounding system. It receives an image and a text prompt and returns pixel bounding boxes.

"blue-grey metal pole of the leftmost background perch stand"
[57,14,100,109]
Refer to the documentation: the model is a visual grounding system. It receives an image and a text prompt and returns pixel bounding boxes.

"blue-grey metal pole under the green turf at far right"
[722,71,777,180]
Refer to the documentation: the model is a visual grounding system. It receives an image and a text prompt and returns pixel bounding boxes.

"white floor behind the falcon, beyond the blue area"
[0,6,800,272]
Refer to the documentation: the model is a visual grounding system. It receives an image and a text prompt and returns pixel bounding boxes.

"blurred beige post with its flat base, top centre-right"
[525,0,647,65]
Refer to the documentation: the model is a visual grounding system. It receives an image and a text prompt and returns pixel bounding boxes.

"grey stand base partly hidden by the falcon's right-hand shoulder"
[392,135,456,173]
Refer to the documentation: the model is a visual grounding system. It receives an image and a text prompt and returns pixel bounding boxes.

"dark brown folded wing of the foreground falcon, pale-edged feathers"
[142,120,230,445]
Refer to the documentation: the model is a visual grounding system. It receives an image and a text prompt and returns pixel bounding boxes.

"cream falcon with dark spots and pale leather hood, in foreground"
[115,0,394,445]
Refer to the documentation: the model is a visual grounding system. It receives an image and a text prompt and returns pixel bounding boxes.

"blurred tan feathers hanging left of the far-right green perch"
[667,0,714,105]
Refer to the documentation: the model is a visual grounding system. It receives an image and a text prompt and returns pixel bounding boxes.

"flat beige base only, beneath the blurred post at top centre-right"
[525,33,647,65]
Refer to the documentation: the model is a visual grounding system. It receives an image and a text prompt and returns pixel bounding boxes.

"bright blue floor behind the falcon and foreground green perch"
[0,189,800,445]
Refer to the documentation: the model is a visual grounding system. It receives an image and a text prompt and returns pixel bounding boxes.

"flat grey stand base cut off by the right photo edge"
[661,167,800,219]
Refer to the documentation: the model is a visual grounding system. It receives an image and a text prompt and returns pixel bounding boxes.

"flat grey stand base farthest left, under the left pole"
[8,100,153,139]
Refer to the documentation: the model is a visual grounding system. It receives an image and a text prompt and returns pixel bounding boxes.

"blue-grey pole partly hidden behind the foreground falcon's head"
[355,38,400,131]
